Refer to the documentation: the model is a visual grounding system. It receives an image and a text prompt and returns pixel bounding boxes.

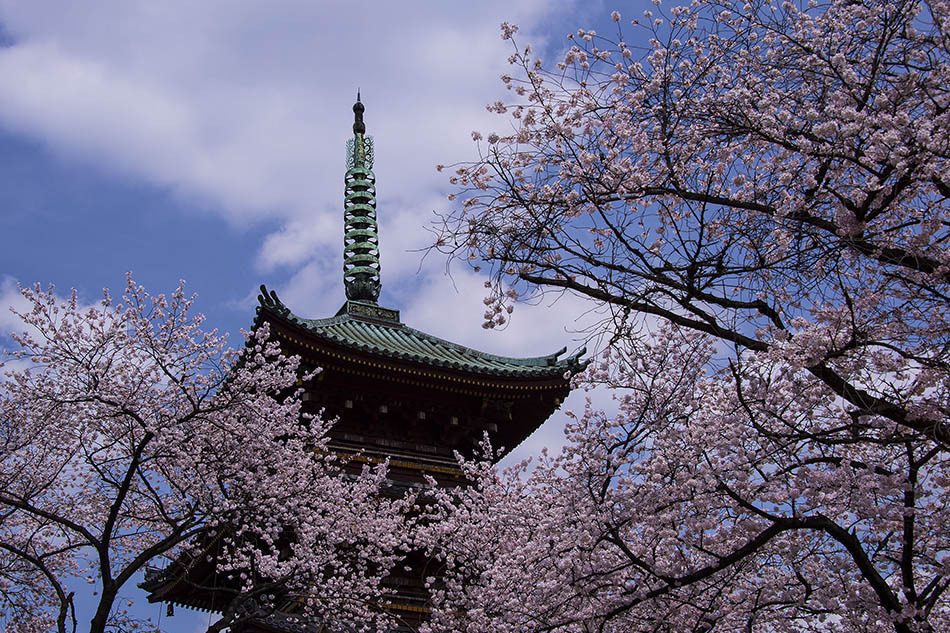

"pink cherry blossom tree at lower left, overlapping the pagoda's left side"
[0,279,402,633]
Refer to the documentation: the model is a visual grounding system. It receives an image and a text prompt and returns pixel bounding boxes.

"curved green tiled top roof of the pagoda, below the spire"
[258,286,587,378]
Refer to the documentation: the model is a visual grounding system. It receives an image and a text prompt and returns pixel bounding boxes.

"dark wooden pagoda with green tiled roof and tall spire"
[143,95,586,633]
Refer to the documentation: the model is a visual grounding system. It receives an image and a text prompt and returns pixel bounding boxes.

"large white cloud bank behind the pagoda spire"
[0,0,608,460]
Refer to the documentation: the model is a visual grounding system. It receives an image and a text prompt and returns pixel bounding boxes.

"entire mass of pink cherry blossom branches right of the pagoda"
[428,0,950,633]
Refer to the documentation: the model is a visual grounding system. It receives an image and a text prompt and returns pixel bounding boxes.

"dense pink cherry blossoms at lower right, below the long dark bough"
[417,325,950,633]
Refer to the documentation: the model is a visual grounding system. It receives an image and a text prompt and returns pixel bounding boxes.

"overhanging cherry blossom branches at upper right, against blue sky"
[437,0,950,445]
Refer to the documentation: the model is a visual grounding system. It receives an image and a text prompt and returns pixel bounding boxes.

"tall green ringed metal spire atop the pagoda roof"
[343,91,380,303]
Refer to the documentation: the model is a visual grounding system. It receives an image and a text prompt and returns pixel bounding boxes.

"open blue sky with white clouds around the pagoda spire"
[0,0,620,624]
